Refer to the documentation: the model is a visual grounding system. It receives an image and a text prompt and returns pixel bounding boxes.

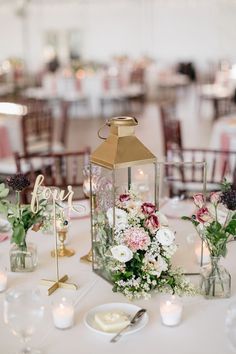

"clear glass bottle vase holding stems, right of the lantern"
[201,257,231,299]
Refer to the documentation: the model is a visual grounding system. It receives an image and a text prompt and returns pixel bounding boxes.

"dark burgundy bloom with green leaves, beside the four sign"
[0,174,45,251]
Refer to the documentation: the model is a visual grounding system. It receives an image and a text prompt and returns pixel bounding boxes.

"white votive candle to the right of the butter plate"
[160,296,183,326]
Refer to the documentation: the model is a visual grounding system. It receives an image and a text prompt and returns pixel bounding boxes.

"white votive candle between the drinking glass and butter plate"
[52,298,75,329]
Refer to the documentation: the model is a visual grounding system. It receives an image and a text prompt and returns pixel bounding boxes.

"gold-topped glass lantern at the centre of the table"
[90,117,157,282]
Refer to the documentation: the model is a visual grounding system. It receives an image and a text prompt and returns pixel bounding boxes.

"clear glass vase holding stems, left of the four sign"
[10,243,38,272]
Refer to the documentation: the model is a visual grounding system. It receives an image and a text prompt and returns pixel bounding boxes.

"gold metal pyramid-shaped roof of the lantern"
[90,117,156,169]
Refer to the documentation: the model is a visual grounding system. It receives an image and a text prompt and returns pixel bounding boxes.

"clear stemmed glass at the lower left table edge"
[3,288,45,354]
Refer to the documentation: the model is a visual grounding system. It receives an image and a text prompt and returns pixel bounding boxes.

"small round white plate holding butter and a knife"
[84,302,148,336]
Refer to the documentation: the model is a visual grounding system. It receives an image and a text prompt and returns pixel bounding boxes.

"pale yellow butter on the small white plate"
[94,311,130,333]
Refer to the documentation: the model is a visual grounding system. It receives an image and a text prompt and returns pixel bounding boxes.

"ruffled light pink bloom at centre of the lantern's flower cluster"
[124,227,150,252]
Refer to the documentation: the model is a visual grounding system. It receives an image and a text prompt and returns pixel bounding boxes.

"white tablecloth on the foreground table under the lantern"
[0,205,236,354]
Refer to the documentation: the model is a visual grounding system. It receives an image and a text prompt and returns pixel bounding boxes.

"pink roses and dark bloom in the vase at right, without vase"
[182,181,236,257]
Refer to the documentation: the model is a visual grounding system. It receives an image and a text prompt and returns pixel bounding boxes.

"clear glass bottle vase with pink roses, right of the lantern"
[182,180,236,299]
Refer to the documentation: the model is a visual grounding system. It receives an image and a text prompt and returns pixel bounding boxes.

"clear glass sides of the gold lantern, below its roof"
[91,163,157,282]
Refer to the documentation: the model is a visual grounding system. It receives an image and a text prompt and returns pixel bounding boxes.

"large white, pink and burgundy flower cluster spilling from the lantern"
[96,191,194,299]
